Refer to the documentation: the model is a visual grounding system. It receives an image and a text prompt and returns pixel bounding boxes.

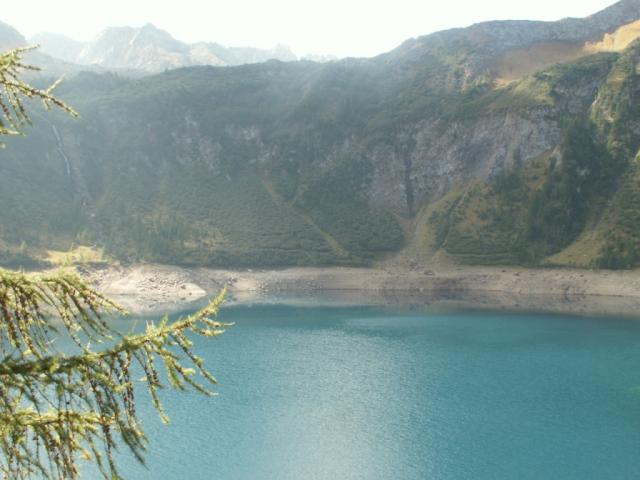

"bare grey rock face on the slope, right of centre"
[370,110,561,216]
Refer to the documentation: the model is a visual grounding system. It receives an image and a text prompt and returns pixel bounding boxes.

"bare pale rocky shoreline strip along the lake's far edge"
[76,264,640,318]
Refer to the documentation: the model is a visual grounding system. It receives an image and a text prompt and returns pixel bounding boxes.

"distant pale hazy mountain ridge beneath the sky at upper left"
[31,24,297,72]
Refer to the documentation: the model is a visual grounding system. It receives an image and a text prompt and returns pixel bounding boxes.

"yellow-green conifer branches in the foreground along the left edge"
[0,48,228,479]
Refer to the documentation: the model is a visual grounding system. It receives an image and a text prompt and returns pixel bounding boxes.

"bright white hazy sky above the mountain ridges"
[0,0,615,56]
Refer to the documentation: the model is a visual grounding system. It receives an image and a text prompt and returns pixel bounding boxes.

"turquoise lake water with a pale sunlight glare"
[95,307,640,480]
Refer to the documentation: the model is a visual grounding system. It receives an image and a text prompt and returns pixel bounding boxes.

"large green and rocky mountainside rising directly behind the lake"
[0,0,640,268]
